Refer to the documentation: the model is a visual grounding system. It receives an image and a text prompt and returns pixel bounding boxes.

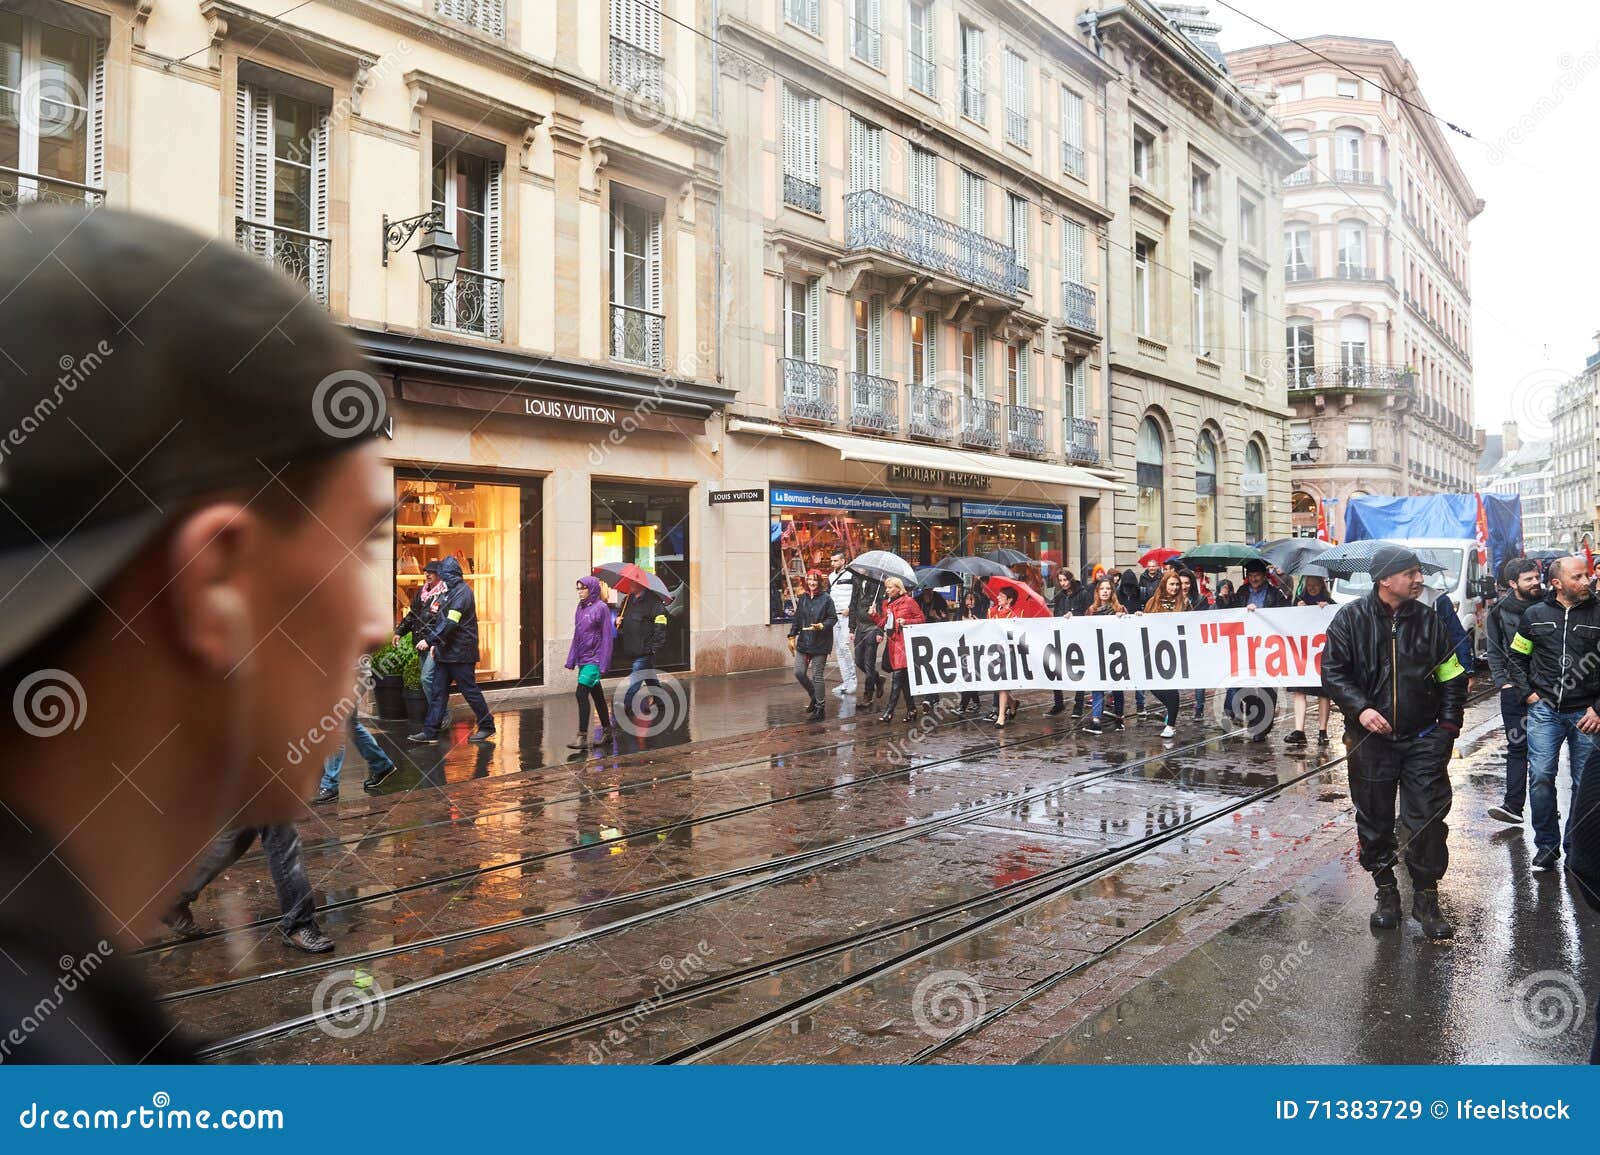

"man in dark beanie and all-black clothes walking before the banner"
[1322,546,1467,939]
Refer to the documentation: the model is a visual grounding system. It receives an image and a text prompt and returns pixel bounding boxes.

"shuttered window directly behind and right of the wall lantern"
[432,135,504,341]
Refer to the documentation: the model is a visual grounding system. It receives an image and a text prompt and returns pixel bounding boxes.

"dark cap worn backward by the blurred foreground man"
[0,206,386,664]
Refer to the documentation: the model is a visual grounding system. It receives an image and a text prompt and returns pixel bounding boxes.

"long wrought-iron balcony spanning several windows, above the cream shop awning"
[845,190,1018,298]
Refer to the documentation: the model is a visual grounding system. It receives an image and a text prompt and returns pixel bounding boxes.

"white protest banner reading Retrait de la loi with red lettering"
[906,606,1338,694]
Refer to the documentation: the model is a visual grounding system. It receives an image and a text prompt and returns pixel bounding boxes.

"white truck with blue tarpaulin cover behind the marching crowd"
[1333,493,1523,659]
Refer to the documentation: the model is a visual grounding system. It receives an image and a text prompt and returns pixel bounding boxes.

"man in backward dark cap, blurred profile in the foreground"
[0,206,390,1062]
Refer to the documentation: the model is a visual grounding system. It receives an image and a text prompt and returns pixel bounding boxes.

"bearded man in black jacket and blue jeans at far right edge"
[1506,557,1600,870]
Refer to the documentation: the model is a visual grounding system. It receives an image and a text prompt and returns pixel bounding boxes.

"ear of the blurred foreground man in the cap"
[160,502,264,675]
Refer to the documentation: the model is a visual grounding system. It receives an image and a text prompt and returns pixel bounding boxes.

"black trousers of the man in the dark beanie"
[1344,729,1454,889]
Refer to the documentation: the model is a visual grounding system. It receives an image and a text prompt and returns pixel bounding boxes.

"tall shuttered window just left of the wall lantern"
[233,81,333,304]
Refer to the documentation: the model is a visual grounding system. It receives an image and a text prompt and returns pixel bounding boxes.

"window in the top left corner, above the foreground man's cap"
[0,11,106,208]
